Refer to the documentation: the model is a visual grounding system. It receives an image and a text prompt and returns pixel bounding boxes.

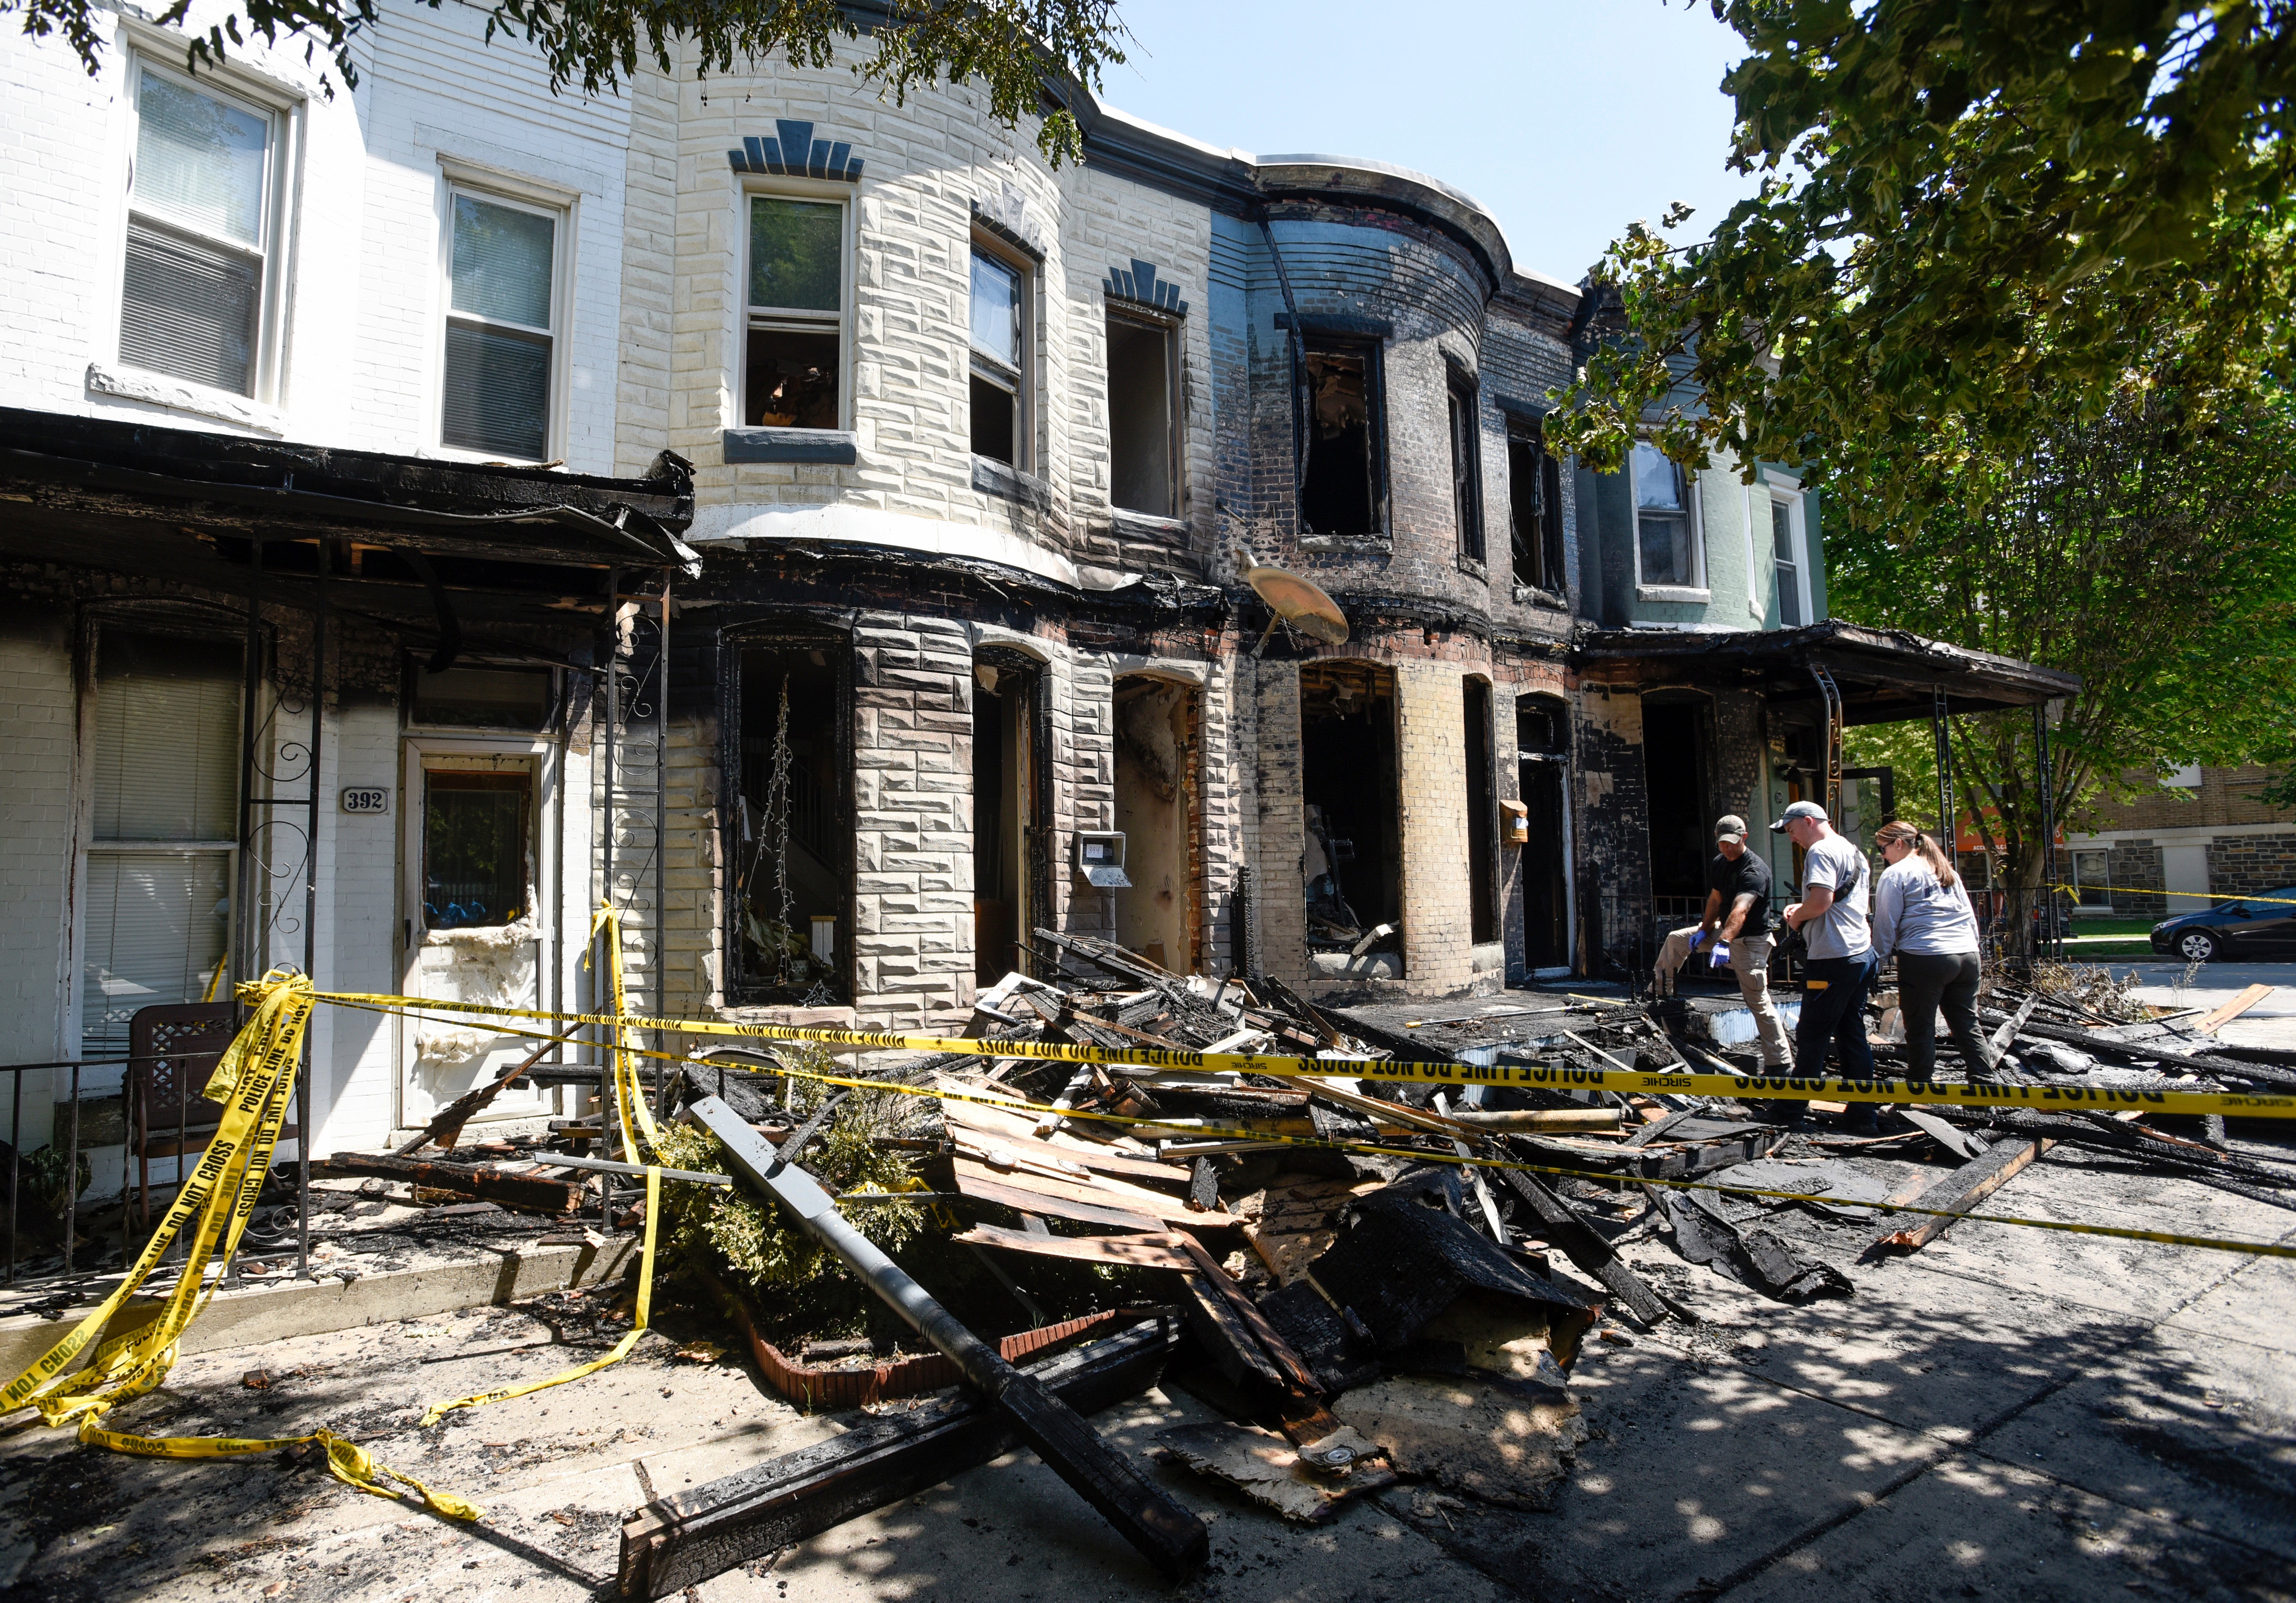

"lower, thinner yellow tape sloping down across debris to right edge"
[319,978,2296,1258]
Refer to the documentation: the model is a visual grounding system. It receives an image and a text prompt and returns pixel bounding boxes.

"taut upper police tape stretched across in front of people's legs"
[273,974,2296,1118]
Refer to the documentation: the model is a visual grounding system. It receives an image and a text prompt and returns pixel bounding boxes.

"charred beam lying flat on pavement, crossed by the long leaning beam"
[618,1316,1180,1599]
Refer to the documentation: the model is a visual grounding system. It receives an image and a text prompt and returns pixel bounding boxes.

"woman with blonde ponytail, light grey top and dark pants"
[1873,822,1986,1079]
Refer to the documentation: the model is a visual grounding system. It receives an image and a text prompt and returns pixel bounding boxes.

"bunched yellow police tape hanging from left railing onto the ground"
[0,974,480,1520]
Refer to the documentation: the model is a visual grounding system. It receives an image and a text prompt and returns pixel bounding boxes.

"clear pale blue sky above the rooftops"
[1104,0,1752,282]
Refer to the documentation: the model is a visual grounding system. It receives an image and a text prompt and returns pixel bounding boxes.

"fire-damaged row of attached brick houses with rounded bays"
[0,0,2064,1190]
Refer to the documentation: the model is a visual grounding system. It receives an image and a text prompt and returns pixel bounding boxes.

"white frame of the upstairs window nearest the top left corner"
[112,51,303,411]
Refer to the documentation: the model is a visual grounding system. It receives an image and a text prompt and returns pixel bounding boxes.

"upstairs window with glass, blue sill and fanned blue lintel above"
[742,195,845,430]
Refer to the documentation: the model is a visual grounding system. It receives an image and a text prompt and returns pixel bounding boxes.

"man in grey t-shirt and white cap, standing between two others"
[1770,802,1880,1135]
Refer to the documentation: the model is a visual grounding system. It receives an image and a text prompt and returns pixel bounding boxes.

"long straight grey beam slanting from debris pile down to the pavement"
[687,1098,1212,1580]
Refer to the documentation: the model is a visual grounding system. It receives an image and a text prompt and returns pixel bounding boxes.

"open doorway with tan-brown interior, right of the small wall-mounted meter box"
[1116,675,1203,974]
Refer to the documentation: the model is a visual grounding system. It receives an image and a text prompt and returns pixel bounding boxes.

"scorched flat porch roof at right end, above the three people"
[1573,620,2080,723]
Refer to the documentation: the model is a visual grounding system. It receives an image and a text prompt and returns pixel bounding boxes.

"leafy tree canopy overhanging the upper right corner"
[1548,0,2296,515]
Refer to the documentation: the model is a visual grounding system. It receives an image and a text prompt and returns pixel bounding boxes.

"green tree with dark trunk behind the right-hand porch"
[1828,386,2296,951]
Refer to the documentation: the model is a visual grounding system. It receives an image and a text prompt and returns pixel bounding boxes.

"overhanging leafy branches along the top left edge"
[0,0,1130,163]
